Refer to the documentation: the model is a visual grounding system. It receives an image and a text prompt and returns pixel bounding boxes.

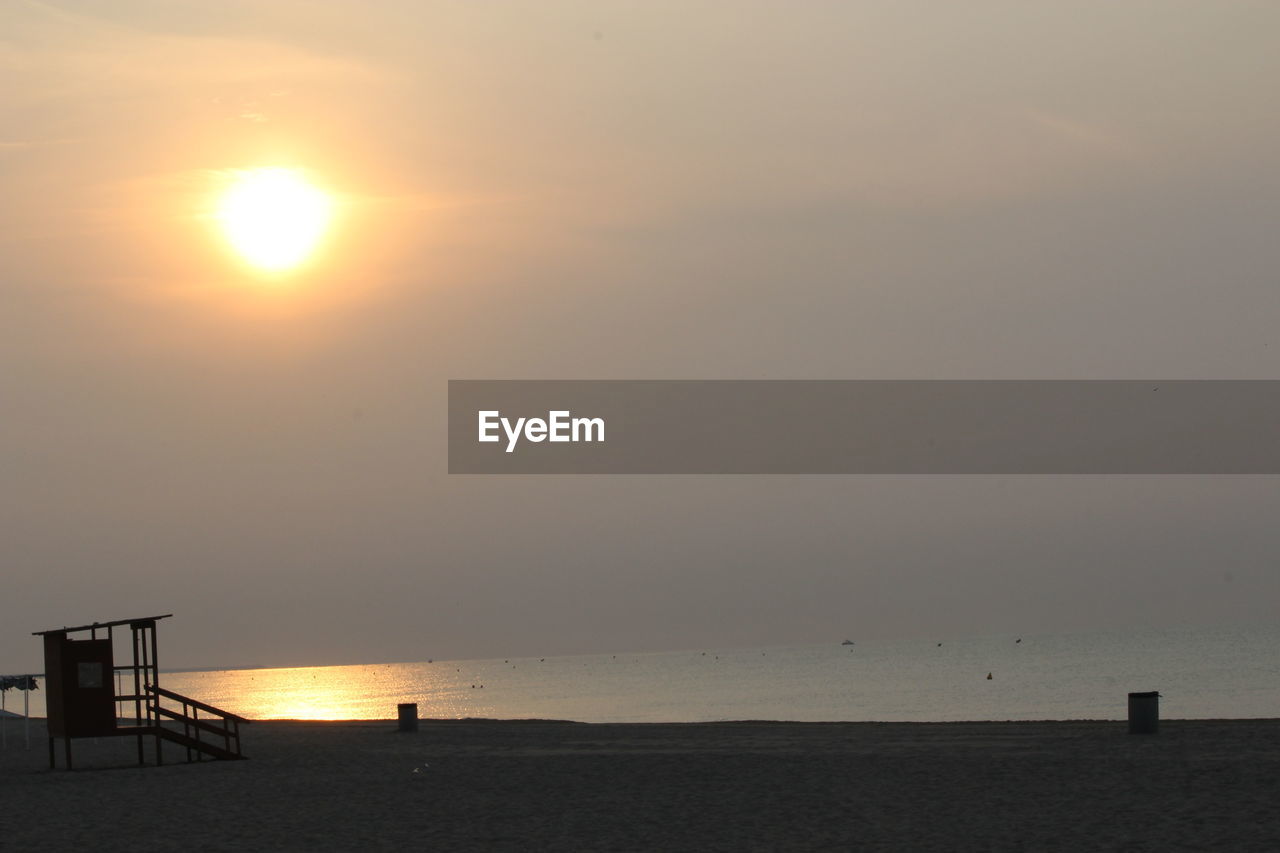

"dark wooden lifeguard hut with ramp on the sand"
[35,613,247,770]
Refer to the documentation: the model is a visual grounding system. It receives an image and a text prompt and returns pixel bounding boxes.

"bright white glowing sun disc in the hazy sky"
[218,167,333,273]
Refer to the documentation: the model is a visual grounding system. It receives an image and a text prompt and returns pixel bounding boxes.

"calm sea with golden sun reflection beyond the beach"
[8,622,1280,722]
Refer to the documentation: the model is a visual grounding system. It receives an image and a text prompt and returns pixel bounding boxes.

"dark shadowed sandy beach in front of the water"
[0,720,1280,850]
